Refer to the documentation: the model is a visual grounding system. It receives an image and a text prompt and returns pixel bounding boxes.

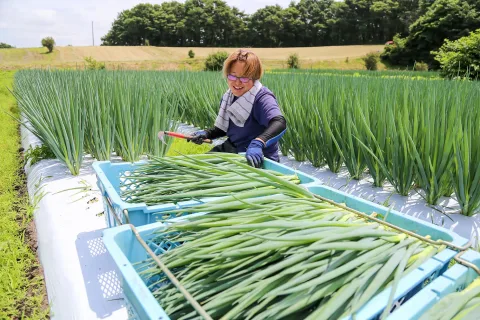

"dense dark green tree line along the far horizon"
[102,0,480,67]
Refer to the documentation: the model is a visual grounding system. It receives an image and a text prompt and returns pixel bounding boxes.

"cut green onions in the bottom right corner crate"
[420,278,480,320]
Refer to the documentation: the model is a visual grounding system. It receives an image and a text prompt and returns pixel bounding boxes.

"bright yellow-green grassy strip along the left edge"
[0,71,49,319]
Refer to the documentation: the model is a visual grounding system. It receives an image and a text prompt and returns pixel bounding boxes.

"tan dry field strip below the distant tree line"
[0,45,383,68]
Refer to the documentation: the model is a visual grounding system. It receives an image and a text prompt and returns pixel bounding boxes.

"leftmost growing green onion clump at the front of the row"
[13,70,87,175]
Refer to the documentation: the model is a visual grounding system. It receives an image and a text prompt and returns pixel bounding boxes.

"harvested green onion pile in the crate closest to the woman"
[121,154,307,205]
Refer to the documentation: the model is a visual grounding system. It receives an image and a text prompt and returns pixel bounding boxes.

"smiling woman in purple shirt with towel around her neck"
[191,50,287,168]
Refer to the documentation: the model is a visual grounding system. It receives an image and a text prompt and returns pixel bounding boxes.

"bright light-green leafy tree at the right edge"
[432,29,480,80]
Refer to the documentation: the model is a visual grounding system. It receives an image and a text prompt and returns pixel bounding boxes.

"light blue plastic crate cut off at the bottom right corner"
[388,250,480,320]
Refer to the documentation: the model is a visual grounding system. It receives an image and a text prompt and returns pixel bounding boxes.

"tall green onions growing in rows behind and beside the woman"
[13,70,480,215]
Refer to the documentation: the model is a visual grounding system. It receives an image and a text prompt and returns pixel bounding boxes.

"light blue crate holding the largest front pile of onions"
[104,186,468,320]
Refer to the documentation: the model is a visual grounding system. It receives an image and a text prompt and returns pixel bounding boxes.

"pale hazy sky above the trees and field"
[0,0,291,48]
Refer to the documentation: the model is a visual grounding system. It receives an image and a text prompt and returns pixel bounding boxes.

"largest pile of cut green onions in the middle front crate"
[137,195,443,319]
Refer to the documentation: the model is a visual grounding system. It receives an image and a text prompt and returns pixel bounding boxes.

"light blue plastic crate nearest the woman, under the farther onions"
[93,159,319,228]
